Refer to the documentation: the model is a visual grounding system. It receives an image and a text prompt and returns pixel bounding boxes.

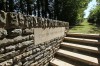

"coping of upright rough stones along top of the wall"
[0,11,69,29]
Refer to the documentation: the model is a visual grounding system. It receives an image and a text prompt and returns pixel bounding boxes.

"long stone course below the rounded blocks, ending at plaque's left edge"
[0,35,33,47]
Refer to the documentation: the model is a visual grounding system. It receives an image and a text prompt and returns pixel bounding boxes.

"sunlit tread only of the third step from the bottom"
[61,42,98,51]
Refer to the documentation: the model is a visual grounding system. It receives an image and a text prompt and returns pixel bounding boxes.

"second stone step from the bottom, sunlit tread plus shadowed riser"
[56,49,98,66]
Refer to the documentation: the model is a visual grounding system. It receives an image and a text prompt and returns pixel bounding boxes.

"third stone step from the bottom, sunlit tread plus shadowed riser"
[61,42,100,57]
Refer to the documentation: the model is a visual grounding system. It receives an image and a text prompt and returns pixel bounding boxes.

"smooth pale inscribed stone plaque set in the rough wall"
[34,27,65,45]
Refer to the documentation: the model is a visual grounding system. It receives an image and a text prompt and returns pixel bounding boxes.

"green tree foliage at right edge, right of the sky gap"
[88,0,100,25]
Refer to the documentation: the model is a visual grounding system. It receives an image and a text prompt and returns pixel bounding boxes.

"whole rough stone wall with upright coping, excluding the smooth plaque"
[0,11,68,66]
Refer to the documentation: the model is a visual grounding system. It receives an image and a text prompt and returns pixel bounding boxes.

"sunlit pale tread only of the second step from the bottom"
[56,49,98,64]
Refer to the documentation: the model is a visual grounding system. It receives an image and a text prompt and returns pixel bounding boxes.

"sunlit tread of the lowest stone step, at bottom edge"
[50,58,74,66]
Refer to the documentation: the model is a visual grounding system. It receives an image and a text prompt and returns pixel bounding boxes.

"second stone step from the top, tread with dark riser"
[63,37,100,47]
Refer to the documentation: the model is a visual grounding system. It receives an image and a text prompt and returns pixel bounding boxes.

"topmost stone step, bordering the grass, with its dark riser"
[66,33,100,39]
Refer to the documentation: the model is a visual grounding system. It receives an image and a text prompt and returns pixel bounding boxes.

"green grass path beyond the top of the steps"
[69,20,100,34]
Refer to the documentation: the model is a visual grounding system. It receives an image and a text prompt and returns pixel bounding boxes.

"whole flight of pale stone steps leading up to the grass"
[50,33,100,66]
